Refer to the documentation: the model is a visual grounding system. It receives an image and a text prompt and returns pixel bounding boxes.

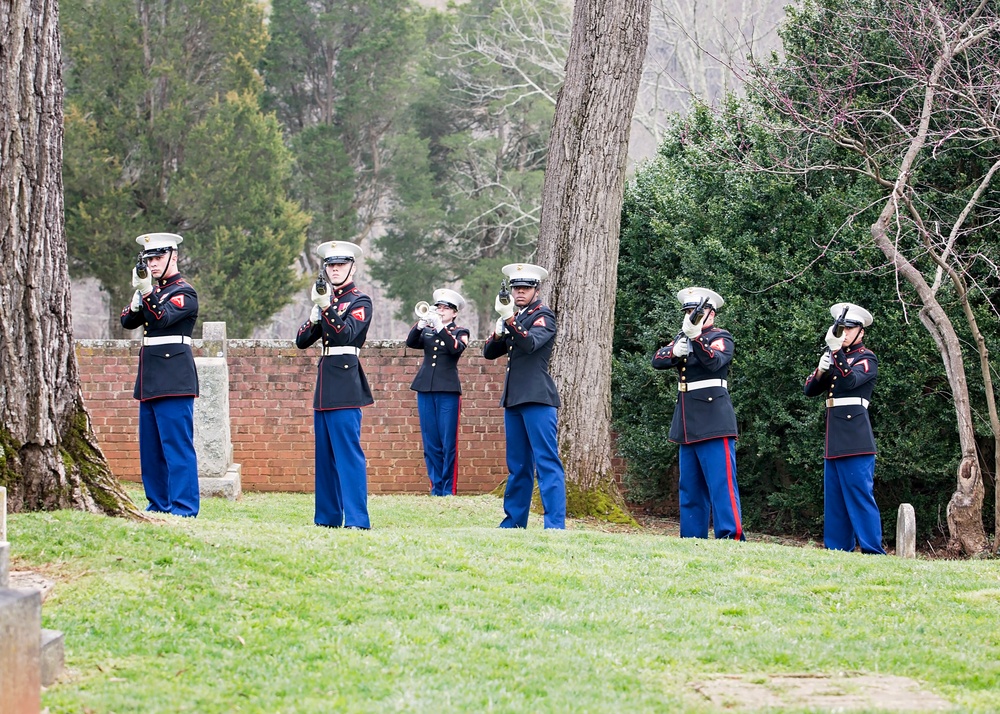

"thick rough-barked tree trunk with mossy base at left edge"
[0,0,141,517]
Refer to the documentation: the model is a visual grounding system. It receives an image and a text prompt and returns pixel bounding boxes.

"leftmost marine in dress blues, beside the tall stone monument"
[121,233,200,516]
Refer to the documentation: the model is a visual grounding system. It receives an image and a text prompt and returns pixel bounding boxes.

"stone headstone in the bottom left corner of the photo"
[0,589,42,714]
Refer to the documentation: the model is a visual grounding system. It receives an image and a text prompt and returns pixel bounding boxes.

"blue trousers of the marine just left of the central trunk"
[500,404,566,528]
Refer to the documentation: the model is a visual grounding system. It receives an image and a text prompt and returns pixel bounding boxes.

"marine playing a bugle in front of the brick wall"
[406,288,470,496]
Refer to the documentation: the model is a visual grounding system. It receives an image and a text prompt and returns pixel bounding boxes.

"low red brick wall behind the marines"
[76,340,507,493]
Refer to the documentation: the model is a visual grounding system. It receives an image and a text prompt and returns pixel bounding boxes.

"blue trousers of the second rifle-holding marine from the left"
[313,408,371,528]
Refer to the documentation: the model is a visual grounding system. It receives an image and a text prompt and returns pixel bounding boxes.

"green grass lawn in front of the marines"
[9,494,1000,712]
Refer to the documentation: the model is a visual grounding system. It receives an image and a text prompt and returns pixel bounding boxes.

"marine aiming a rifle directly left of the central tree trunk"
[483,263,566,528]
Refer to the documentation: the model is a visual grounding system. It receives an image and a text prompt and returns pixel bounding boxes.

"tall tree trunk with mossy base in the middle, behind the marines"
[538,0,651,520]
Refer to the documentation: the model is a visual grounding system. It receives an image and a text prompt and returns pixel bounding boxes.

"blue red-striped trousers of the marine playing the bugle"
[417,392,462,496]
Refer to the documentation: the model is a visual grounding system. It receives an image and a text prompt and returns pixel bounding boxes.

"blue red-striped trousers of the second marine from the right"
[678,437,746,540]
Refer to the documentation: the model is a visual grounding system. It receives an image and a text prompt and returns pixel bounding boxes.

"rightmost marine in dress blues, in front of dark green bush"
[803,303,885,555]
